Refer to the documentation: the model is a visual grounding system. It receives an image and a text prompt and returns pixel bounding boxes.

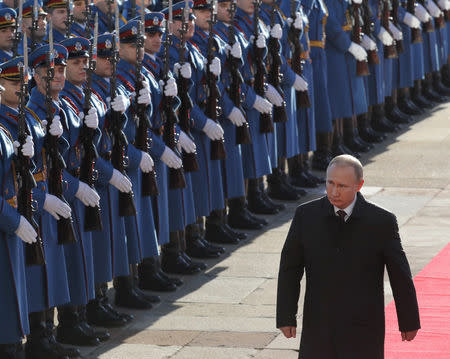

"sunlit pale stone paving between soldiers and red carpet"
[83,104,450,359]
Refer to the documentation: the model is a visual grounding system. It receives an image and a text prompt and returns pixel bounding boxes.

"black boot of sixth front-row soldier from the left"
[138,257,177,292]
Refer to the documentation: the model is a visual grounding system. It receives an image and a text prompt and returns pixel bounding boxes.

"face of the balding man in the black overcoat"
[326,164,364,209]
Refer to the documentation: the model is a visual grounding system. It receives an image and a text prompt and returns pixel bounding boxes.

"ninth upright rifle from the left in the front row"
[227,0,252,145]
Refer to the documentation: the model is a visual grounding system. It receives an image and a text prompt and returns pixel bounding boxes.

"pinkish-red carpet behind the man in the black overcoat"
[385,244,450,359]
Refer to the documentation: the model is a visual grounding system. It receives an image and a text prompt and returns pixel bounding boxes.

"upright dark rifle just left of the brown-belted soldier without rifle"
[288,0,311,108]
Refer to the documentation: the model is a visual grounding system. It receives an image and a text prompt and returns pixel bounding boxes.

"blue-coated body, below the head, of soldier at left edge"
[0,107,37,359]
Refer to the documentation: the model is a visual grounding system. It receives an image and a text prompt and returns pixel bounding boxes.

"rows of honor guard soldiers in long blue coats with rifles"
[0,0,450,359]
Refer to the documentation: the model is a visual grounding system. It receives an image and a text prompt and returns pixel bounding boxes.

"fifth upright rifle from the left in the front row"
[134,3,159,197]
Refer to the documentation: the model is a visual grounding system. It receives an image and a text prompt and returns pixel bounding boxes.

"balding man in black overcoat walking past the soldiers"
[277,155,420,359]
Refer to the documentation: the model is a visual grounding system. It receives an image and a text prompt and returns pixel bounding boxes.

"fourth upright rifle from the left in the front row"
[108,4,136,217]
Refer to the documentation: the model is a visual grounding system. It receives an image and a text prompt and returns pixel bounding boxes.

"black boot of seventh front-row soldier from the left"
[161,232,201,275]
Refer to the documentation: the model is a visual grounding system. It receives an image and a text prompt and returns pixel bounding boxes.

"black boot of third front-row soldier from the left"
[56,305,100,346]
